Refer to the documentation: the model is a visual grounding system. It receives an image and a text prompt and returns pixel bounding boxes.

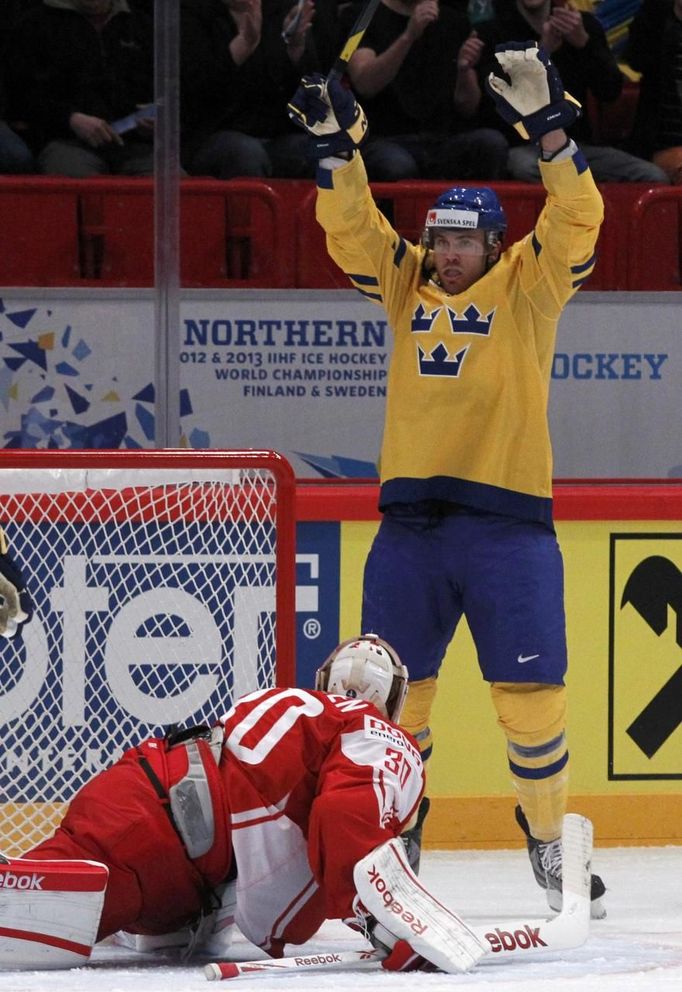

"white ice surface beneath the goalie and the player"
[0,847,682,992]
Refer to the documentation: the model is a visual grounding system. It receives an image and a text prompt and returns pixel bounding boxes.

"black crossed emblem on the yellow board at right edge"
[620,555,682,758]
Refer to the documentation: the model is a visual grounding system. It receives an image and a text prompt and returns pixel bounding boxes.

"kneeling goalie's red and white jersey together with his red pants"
[29,689,424,955]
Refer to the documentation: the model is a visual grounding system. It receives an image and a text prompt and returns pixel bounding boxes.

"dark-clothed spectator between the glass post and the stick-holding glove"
[181,0,317,179]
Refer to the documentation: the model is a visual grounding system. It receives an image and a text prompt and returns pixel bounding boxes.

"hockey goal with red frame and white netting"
[0,450,295,856]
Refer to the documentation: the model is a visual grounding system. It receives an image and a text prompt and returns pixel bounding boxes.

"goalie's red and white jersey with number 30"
[221,689,424,950]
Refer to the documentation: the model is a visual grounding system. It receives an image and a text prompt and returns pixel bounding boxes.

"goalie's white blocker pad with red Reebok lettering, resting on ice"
[353,840,489,973]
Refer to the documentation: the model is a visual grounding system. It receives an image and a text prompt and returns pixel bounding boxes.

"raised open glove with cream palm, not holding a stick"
[486,41,582,141]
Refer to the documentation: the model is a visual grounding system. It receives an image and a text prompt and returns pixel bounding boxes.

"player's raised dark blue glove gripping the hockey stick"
[288,72,367,158]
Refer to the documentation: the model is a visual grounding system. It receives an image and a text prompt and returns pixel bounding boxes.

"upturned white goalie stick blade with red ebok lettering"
[474,813,592,964]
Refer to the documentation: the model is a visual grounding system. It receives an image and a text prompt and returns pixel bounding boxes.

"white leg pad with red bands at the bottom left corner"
[0,858,109,969]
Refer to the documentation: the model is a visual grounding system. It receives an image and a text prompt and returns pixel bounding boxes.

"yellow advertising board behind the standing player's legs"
[340,520,682,847]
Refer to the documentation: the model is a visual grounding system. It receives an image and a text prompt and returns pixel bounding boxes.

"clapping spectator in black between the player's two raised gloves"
[338,0,508,181]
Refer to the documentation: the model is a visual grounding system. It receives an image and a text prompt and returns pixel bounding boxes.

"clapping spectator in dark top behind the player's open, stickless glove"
[470,0,668,183]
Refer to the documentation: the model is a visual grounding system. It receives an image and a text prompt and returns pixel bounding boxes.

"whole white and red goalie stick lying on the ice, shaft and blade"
[204,813,592,981]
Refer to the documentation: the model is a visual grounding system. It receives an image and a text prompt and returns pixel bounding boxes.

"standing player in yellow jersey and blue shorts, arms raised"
[289,42,605,917]
